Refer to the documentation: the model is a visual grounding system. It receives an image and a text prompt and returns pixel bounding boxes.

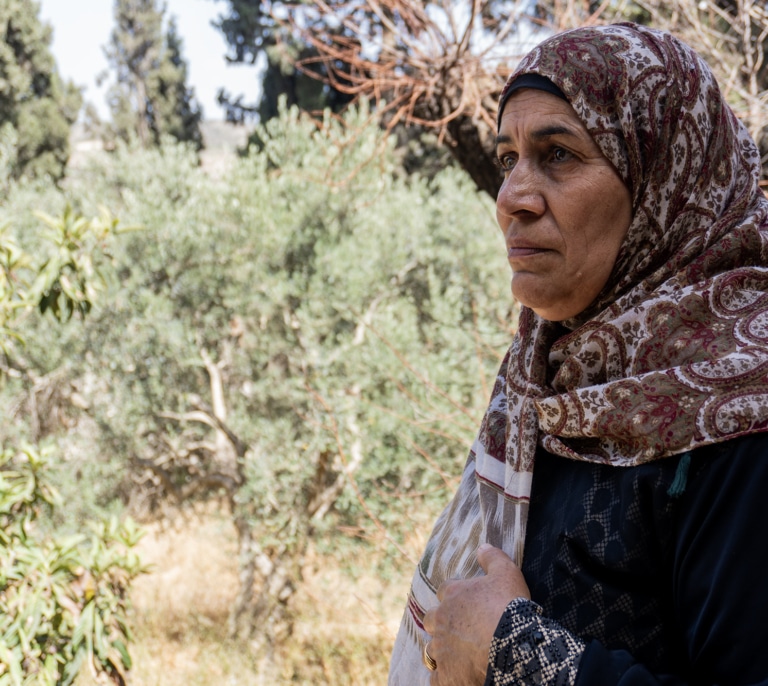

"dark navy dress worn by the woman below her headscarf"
[486,434,768,686]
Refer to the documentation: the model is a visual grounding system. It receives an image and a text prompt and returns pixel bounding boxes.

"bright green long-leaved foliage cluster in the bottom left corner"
[0,446,145,686]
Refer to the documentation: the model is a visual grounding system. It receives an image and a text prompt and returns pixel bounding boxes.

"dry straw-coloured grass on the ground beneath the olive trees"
[78,514,410,686]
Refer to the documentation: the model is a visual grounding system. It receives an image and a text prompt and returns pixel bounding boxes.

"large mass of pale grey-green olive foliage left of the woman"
[67,101,514,548]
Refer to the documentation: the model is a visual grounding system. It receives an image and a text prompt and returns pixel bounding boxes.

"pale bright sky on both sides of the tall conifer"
[38,0,259,120]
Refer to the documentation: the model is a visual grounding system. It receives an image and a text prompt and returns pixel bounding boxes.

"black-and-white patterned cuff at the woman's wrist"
[484,598,585,686]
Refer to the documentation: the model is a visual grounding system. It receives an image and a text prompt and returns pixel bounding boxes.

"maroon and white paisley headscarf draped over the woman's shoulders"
[390,23,768,685]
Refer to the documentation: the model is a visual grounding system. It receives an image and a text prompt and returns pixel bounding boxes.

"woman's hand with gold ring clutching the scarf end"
[424,544,531,686]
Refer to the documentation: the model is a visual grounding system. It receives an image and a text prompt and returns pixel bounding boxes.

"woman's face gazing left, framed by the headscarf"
[496,88,632,321]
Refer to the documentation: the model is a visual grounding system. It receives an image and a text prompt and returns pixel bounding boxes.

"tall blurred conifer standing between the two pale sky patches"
[107,0,203,150]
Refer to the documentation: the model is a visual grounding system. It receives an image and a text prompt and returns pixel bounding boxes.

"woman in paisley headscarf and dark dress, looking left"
[390,24,768,686]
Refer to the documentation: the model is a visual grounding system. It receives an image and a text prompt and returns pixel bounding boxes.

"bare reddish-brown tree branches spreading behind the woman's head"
[210,0,768,197]
